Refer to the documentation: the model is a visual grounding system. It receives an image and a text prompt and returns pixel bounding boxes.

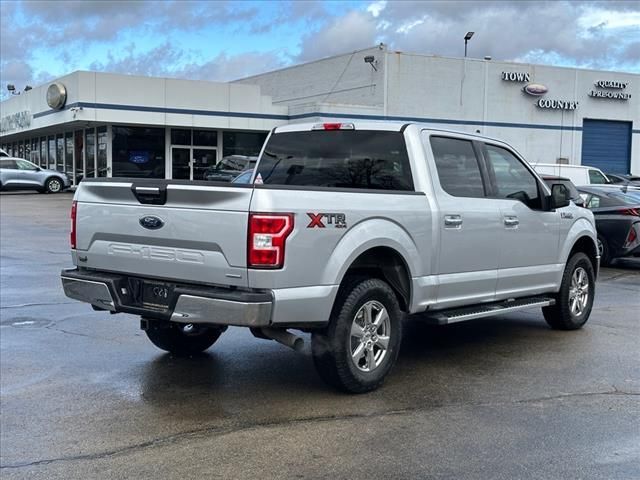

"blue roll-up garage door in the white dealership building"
[582,119,631,173]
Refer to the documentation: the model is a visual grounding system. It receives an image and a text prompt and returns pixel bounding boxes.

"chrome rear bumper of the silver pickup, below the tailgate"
[61,269,273,327]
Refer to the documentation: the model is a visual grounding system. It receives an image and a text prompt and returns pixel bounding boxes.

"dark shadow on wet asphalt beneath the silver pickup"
[136,315,553,420]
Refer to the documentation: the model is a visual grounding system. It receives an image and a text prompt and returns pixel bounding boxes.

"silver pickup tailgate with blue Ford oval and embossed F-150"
[75,179,253,287]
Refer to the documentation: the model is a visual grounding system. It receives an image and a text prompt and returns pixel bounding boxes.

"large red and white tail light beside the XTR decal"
[247,213,293,269]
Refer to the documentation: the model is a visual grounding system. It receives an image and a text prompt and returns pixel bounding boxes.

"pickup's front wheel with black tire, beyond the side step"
[542,253,595,330]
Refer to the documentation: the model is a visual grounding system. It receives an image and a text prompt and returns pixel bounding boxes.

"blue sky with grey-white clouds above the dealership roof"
[0,0,640,95]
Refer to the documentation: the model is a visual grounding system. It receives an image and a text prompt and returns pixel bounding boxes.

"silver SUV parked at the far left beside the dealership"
[0,157,71,193]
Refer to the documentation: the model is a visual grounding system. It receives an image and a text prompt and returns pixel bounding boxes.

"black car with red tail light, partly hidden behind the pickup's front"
[578,187,640,265]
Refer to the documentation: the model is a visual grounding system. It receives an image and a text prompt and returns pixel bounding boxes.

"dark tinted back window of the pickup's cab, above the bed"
[256,130,414,190]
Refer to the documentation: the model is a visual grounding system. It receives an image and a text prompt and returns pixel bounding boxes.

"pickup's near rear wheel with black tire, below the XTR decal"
[311,279,403,393]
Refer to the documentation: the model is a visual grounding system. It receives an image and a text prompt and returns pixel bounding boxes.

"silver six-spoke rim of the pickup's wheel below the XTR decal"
[350,300,391,372]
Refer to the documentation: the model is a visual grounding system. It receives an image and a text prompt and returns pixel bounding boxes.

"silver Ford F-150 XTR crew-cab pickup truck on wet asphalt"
[62,123,599,392]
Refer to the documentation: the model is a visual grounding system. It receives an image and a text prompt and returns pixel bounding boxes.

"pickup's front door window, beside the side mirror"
[485,145,542,208]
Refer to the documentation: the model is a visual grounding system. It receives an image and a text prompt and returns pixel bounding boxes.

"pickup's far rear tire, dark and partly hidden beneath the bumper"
[146,321,225,356]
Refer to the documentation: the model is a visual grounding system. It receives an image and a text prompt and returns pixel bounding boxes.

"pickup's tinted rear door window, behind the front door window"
[431,137,485,197]
